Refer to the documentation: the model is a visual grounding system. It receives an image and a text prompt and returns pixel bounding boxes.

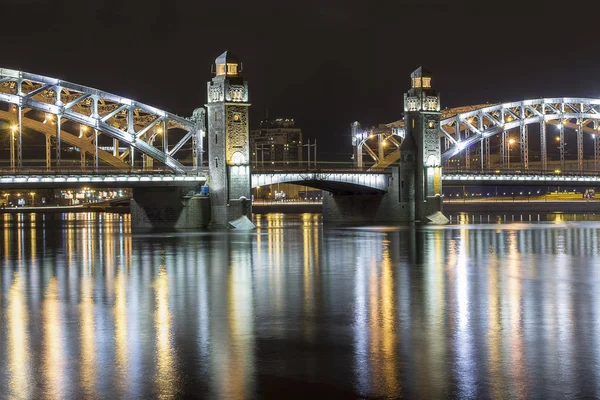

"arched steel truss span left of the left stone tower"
[0,68,206,173]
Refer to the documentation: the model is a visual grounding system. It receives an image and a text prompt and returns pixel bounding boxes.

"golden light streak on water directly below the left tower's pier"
[154,264,176,397]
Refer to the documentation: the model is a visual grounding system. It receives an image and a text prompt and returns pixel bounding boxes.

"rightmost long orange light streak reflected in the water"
[504,231,527,398]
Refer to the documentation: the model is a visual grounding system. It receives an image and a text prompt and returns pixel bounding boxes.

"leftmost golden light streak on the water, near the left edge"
[6,272,32,399]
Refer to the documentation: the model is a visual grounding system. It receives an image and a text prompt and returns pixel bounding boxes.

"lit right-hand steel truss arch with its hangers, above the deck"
[351,97,600,171]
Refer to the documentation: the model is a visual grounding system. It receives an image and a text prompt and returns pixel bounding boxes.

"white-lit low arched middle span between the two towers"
[252,174,389,194]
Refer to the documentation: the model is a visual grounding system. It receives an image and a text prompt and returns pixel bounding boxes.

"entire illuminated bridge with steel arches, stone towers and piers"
[0,57,600,228]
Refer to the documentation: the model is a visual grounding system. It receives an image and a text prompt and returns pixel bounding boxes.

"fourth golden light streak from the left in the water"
[113,266,128,394]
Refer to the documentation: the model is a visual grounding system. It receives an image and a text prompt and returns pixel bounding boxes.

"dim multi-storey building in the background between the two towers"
[250,118,302,168]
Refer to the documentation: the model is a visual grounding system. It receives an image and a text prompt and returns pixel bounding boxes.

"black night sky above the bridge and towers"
[0,0,600,160]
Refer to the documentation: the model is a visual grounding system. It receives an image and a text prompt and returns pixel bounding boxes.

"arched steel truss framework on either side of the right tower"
[352,97,600,170]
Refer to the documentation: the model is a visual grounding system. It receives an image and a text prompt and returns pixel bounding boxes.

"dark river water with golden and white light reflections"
[0,214,600,399]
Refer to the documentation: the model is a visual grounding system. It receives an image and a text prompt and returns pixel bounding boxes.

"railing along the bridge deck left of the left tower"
[0,166,208,176]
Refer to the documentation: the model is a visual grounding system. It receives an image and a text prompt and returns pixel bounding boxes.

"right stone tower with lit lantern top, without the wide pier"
[399,67,448,223]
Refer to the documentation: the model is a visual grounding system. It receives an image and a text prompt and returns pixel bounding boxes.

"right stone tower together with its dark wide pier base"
[323,68,442,224]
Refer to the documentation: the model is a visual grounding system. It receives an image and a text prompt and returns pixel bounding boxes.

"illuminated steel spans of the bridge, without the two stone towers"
[0,69,600,193]
